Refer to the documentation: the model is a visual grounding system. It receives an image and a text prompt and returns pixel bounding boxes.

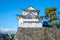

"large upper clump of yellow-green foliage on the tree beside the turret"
[45,7,56,20]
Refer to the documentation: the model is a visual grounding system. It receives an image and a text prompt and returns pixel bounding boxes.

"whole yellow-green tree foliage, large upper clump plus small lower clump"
[45,7,57,26]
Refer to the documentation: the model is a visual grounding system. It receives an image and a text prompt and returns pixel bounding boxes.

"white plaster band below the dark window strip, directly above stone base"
[19,23,42,28]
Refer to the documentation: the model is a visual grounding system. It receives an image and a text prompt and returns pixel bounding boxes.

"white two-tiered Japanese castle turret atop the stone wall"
[17,6,42,28]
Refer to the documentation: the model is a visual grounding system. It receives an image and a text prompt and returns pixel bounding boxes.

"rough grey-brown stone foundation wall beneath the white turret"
[16,27,60,40]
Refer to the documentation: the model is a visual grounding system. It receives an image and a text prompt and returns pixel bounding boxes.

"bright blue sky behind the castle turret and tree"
[0,0,60,32]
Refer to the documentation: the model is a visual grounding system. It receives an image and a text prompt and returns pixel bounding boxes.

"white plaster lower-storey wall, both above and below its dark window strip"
[18,18,42,28]
